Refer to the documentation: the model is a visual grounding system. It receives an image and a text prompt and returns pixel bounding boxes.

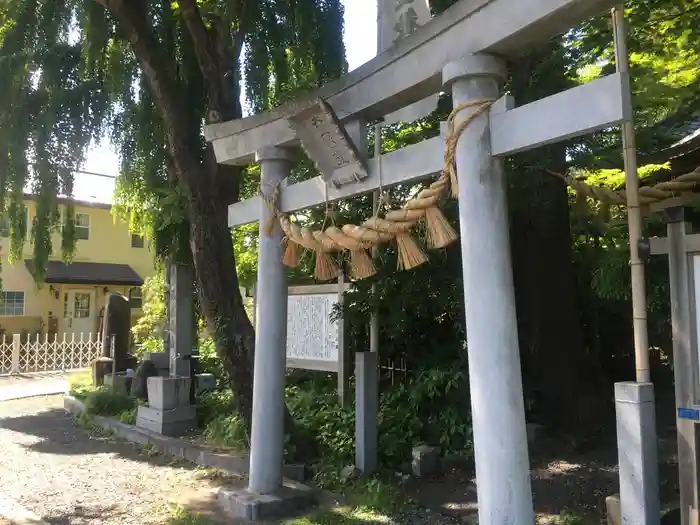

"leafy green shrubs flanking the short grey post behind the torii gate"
[286,363,473,483]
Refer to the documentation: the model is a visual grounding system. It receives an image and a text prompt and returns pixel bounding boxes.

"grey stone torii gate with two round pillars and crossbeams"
[205,0,630,525]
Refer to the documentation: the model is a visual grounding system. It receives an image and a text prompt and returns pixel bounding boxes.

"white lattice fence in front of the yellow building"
[0,334,102,374]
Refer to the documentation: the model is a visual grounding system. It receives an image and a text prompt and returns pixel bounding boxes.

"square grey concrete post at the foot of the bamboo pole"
[613,383,660,525]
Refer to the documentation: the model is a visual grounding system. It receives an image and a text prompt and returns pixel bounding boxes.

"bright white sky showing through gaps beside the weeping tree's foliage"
[75,0,377,202]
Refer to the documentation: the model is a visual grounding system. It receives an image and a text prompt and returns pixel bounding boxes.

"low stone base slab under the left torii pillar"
[217,480,316,521]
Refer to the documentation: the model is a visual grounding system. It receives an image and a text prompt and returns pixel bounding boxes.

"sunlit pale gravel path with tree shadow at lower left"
[0,396,221,525]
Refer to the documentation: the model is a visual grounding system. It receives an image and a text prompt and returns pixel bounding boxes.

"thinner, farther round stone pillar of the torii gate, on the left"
[248,146,292,494]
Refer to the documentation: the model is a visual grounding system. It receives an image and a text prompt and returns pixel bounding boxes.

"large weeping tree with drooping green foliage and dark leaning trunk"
[0,0,346,428]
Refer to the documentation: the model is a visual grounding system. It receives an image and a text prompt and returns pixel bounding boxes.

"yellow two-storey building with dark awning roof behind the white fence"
[0,195,155,339]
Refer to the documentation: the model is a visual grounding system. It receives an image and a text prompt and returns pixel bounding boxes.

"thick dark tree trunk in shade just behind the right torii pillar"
[510,44,603,429]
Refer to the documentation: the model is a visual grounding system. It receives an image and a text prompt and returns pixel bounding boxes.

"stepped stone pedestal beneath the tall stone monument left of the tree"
[136,377,197,436]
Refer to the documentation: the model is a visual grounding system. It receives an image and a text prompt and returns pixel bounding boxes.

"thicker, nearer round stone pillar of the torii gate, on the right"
[442,55,534,525]
